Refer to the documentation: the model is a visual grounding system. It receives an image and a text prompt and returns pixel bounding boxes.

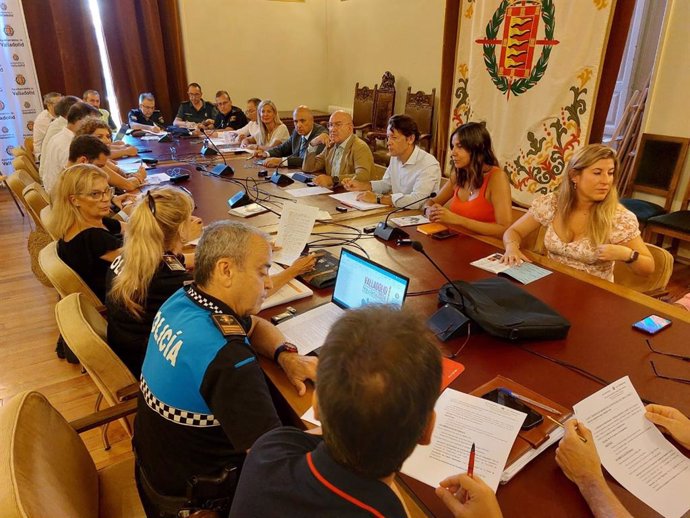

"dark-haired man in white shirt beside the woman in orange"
[343,115,441,209]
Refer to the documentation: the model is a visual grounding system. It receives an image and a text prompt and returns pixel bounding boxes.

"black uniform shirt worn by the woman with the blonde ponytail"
[105,252,191,379]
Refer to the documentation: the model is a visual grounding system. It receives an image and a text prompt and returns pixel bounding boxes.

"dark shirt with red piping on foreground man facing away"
[230,427,407,518]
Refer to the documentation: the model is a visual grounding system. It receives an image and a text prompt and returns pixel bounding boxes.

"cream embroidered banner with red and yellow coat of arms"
[450,0,615,205]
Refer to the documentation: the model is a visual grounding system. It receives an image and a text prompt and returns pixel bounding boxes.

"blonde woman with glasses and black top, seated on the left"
[49,164,125,300]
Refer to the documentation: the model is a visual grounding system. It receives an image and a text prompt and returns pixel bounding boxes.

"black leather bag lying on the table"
[438,277,570,341]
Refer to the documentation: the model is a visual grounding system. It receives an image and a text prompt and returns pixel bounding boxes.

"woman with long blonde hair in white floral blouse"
[503,144,654,281]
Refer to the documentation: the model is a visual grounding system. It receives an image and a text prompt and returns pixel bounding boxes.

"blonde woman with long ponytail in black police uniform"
[106,187,201,378]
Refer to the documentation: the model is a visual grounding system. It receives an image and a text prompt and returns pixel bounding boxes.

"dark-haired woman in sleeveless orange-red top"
[424,122,512,237]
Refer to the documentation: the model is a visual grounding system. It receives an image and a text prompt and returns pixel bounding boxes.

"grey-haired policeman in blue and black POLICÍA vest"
[133,221,317,516]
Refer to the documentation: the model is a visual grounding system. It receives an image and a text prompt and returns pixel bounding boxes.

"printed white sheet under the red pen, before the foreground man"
[401,389,527,491]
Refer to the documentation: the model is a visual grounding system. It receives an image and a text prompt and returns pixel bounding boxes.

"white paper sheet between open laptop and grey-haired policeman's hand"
[277,302,345,354]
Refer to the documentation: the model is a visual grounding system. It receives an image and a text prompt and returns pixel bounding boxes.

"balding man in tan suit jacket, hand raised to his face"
[302,111,374,188]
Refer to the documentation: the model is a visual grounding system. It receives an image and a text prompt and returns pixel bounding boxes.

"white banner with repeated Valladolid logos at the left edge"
[0,0,43,175]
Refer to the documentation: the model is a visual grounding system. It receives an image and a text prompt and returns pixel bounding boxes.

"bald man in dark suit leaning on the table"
[256,106,328,167]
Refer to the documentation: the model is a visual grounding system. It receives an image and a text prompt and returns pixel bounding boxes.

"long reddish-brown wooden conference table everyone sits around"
[121,134,690,518]
